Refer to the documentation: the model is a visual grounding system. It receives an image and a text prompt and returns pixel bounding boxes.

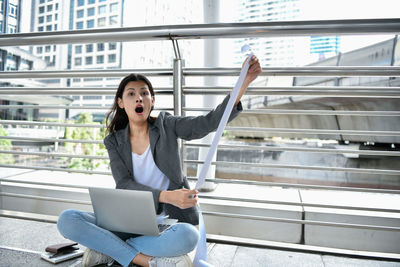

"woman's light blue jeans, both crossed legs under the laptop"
[57,209,199,266]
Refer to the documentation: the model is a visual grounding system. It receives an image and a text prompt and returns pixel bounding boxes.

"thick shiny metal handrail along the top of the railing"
[0,19,400,47]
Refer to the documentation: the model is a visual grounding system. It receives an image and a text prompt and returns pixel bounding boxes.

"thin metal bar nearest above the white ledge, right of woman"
[184,160,400,175]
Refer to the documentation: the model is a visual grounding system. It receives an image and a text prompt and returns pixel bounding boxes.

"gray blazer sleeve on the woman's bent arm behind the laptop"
[104,134,163,213]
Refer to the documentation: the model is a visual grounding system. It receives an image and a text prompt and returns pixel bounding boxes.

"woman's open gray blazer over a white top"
[104,95,242,225]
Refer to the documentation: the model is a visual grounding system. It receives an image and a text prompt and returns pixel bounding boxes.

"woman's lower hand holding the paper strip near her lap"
[159,188,199,209]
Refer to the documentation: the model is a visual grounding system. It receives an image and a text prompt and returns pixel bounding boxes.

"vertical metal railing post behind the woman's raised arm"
[173,58,187,175]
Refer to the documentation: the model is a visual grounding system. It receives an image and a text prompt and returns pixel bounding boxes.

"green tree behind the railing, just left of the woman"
[65,112,106,170]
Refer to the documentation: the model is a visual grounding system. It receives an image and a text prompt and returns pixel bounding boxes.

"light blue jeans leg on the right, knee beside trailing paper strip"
[126,223,199,257]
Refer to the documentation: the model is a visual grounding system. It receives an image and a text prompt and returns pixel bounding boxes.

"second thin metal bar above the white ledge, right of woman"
[184,142,400,157]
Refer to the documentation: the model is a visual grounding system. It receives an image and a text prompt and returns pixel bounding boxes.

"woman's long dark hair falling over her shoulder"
[106,73,155,133]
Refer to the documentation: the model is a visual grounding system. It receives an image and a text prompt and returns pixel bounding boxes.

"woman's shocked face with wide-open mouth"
[118,81,154,122]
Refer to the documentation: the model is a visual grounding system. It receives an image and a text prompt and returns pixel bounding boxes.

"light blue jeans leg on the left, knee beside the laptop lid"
[57,210,138,266]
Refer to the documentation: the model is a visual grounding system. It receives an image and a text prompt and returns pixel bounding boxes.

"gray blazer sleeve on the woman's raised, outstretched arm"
[168,95,243,140]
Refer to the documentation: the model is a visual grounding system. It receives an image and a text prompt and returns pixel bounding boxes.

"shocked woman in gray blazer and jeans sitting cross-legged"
[57,56,262,266]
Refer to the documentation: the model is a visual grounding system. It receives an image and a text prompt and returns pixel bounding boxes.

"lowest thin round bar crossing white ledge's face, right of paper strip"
[202,211,400,231]
